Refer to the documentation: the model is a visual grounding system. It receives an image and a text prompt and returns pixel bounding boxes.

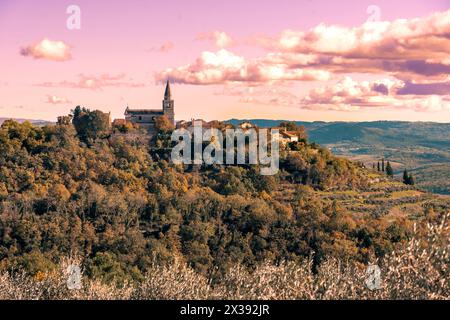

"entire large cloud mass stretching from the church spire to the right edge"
[155,10,450,112]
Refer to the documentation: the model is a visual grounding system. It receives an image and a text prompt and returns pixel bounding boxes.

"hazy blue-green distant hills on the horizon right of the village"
[227,119,450,194]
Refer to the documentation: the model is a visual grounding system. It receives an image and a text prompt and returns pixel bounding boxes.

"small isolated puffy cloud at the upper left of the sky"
[20,38,72,61]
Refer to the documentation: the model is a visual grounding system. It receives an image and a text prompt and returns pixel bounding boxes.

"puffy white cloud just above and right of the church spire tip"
[155,49,330,85]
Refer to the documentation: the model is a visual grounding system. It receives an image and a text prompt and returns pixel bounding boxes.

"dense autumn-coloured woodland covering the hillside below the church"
[0,108,444,282]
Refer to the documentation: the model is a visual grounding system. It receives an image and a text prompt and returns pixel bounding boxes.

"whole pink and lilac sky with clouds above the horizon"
[0,0,450,122]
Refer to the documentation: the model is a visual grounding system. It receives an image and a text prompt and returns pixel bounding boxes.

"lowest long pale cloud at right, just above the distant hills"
[221,77,450,112]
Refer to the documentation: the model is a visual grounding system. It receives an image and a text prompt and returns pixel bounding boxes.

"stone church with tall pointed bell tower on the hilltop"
[125,81,175,131]
